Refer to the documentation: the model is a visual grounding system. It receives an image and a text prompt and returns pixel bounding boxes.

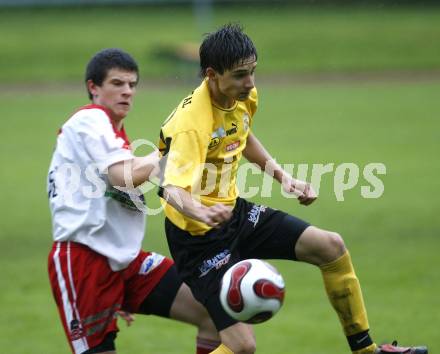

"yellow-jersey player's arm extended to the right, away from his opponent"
[243,133,317,205]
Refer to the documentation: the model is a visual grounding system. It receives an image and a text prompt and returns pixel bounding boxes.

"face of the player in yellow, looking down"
[214,57,257,108]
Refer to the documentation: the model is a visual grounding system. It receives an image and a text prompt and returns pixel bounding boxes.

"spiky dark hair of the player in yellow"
[199,24,257,77]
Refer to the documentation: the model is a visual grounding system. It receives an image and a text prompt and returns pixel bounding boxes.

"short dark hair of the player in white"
[85,48,139,99]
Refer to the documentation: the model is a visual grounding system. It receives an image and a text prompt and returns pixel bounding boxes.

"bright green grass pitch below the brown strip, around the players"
[0,83,440,354]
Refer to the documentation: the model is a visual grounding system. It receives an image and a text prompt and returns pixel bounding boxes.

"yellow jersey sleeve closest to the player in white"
[163,130,206,190]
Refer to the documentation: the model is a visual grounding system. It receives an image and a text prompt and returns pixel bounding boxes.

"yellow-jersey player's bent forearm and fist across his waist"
[163,185,232,227]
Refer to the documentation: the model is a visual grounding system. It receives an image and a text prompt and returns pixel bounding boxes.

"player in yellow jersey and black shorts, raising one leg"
[160,25,427,354]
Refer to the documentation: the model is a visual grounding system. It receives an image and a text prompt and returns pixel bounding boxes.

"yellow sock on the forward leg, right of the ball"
[320,251,369,336]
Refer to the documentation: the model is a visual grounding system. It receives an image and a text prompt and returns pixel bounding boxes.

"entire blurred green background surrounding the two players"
[0,2,440,354]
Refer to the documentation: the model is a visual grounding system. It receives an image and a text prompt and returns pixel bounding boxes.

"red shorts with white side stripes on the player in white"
[49,242,173,354]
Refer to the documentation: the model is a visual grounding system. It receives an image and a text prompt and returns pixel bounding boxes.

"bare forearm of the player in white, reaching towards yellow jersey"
[108,151,160,188]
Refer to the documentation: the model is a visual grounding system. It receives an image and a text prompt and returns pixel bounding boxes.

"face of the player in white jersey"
[88,69,138,122]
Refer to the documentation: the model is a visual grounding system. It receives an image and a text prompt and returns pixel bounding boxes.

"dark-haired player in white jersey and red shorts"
[48,49,219,354]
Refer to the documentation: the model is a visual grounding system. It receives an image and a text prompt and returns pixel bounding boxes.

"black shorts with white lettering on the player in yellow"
[165,198,310,331]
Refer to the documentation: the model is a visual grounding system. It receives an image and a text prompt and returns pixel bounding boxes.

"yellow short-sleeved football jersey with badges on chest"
[159,80,257,235]
